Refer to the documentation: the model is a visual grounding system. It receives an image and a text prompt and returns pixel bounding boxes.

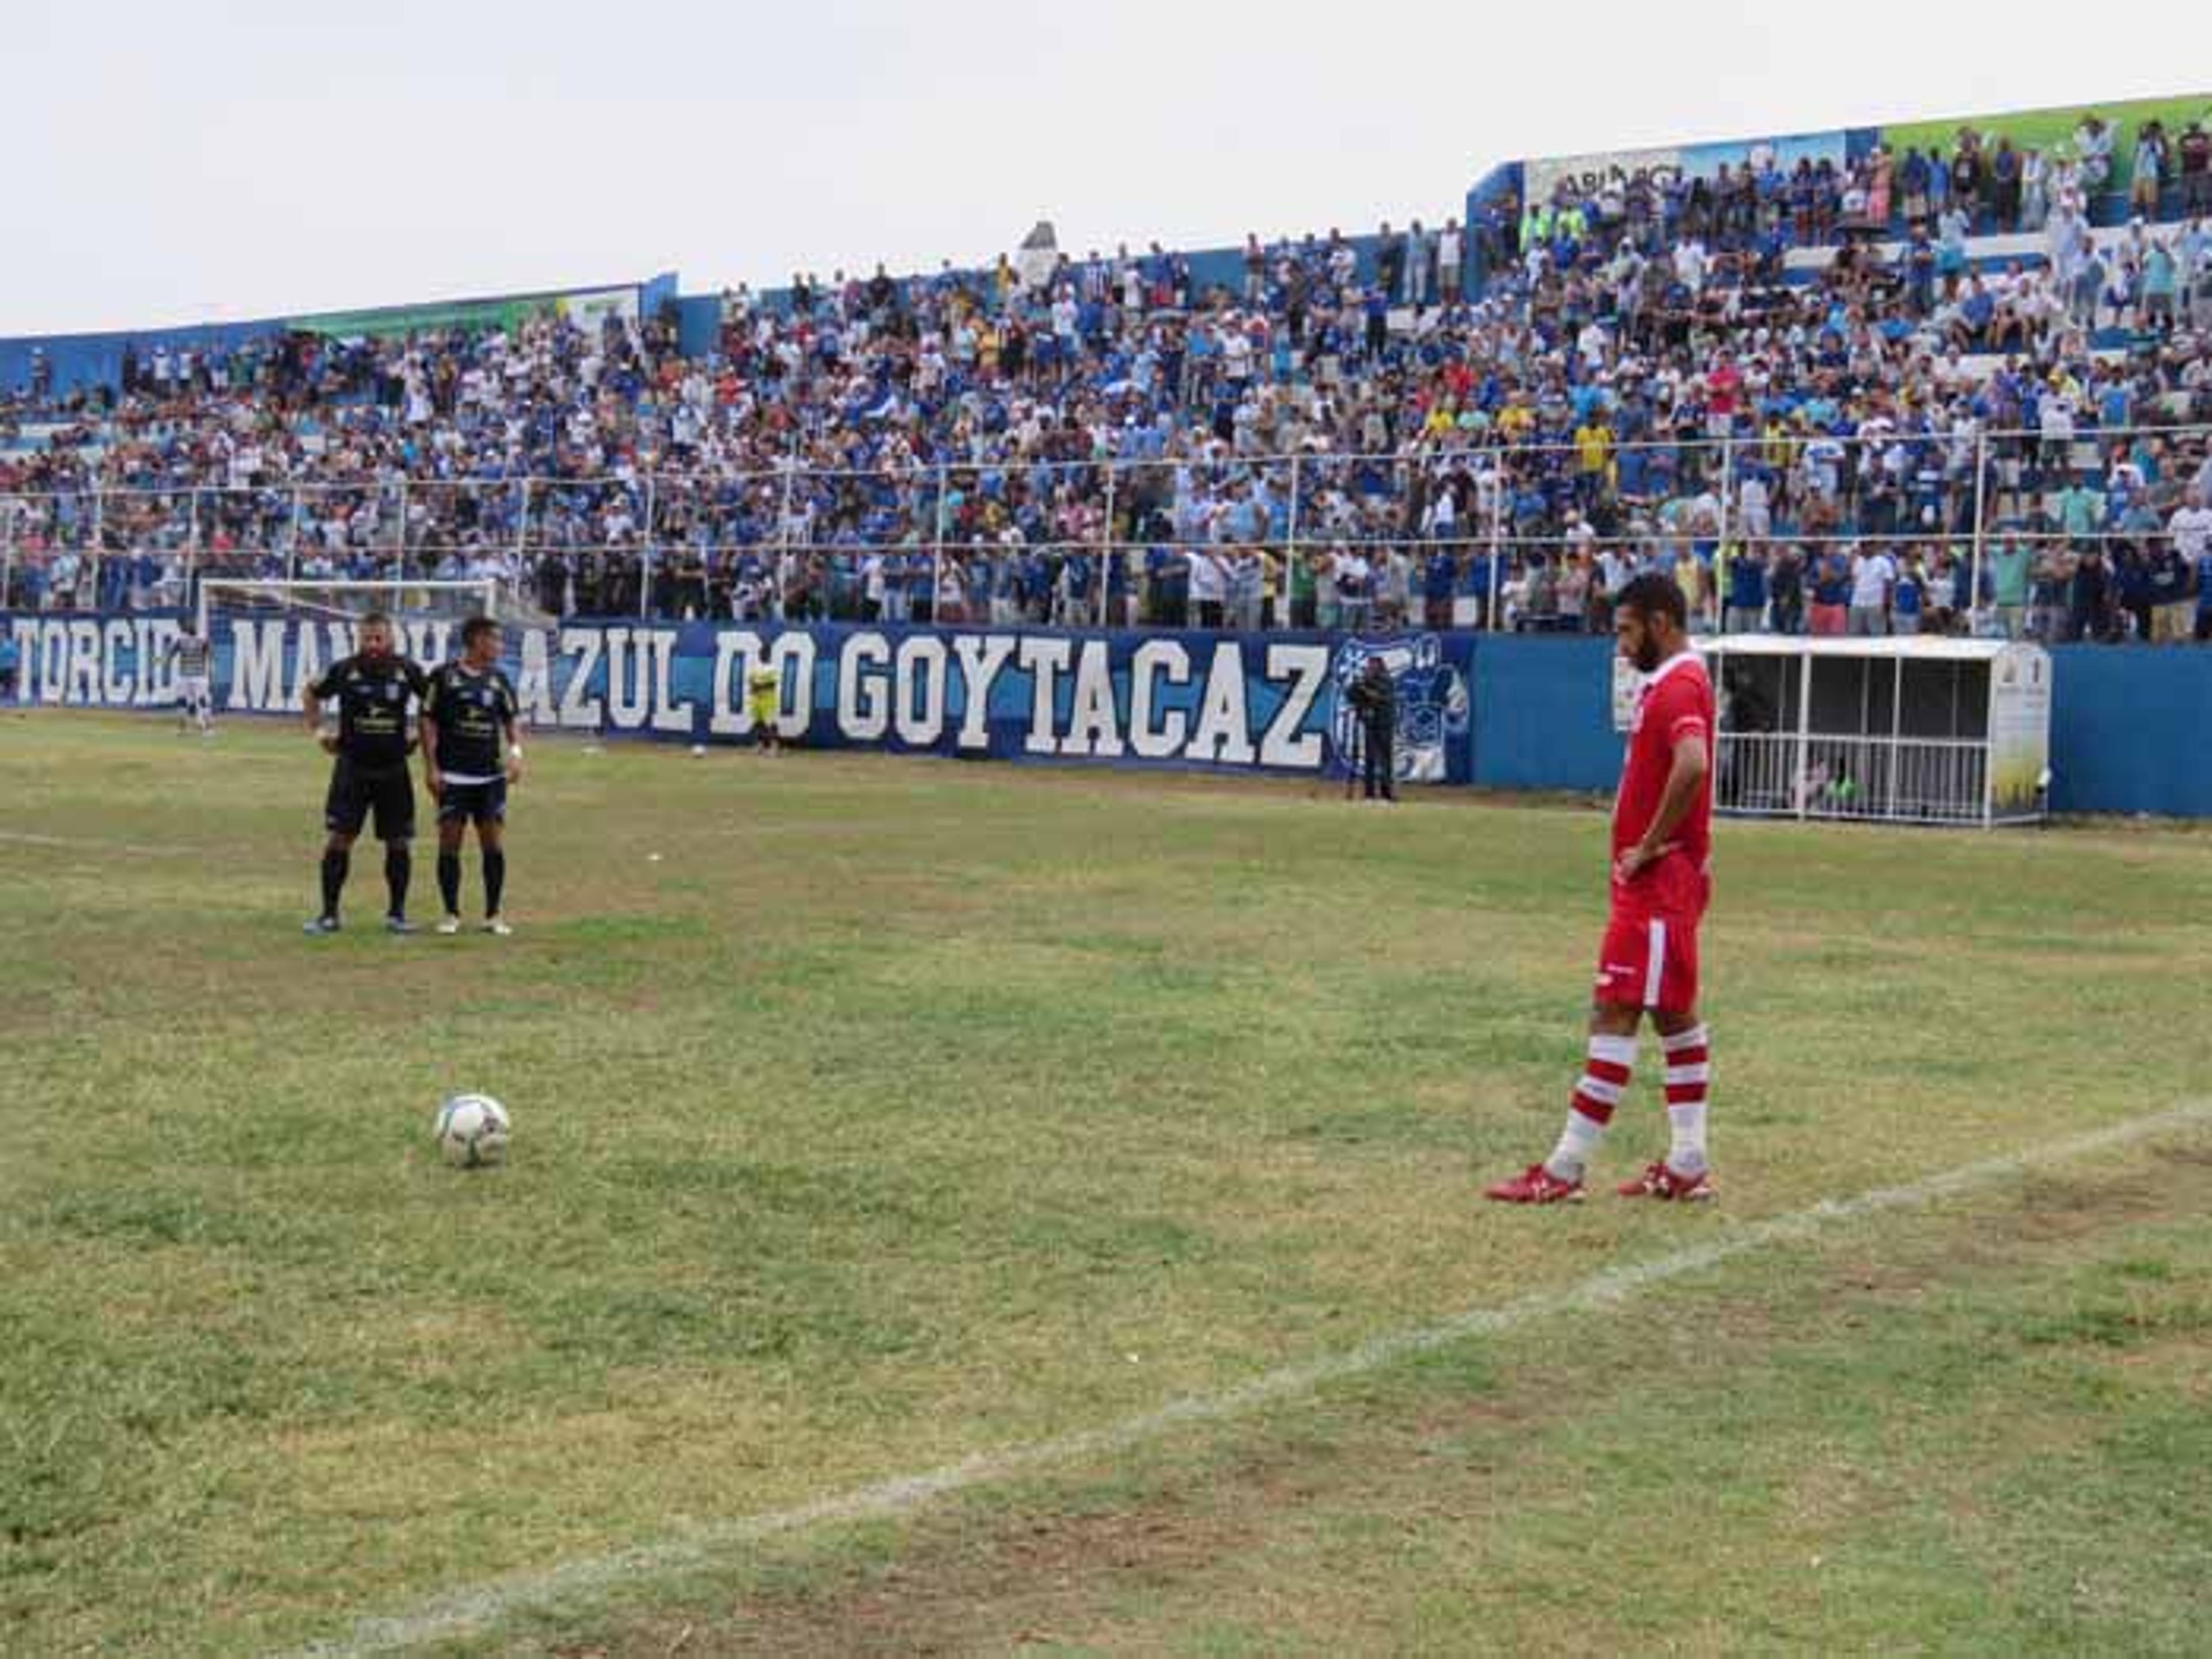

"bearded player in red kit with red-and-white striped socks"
[1486,575,1714,1203]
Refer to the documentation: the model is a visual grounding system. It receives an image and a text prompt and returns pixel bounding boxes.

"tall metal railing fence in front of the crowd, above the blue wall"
[0,422,2212,628]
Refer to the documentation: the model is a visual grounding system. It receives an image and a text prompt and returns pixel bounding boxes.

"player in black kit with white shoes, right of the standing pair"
[422,617,522,938]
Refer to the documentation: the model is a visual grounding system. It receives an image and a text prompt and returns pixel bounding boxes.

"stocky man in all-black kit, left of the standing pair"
[301,611,429,933]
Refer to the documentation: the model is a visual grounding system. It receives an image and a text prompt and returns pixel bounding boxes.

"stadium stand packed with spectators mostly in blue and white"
[0,94,2212,639]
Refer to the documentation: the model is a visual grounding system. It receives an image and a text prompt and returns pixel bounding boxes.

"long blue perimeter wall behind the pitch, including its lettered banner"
[13,613,2212,819]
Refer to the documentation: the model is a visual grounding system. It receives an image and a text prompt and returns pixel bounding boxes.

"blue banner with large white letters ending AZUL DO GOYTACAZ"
[7,613,1475,783]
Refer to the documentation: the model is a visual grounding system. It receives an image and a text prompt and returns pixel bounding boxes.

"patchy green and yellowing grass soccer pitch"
[0,712,2212,1659]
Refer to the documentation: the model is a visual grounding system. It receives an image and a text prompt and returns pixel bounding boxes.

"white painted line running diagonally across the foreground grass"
[276,1099,2212,1659]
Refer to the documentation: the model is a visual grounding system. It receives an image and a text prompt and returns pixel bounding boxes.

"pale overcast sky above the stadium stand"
[0,0,2207,336]
